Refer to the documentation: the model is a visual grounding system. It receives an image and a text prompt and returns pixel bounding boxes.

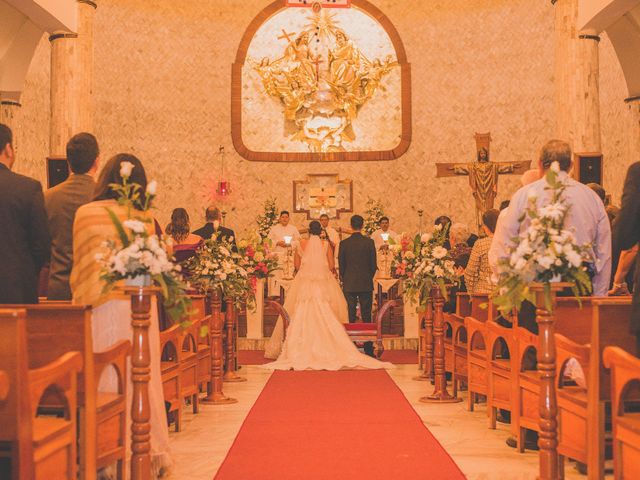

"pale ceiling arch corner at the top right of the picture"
[578,0,640,98]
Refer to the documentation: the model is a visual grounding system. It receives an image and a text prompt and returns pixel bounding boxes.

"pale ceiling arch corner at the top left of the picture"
[0,0,78,102]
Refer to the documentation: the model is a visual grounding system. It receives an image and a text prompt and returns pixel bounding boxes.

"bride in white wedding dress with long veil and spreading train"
[263,221,393,370]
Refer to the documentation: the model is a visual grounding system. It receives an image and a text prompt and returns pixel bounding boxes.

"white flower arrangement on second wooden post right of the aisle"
[391,225,458,308]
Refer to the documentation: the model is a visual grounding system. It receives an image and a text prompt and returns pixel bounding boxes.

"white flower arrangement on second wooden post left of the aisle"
[188,238,255,307]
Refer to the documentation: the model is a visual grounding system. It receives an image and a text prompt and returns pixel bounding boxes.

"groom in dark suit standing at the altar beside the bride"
[338,215,378,323]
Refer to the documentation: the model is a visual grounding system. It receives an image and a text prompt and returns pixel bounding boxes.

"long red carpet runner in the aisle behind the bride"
[212,370,465,480]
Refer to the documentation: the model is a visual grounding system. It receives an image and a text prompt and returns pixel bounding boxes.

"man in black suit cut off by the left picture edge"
[0,123,51,303]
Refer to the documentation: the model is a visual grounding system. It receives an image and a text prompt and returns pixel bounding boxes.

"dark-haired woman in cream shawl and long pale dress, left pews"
[70,153,171,477]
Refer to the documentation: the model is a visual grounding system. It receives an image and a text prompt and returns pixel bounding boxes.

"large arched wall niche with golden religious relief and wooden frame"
[231,0,411,162]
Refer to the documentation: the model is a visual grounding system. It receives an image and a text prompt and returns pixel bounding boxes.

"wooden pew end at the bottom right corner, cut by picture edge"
[603,347,640,480]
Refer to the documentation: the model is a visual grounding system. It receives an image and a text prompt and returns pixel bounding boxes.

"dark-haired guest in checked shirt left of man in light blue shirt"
[464,209,499,294]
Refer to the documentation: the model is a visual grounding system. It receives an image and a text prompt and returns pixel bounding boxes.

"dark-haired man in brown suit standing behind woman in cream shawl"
[44,133,100,300]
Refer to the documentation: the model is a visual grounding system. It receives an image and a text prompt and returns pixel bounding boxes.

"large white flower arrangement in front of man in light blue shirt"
[493,162,593,314]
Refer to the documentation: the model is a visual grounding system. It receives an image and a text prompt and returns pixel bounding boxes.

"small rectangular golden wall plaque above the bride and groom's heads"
[293,173,353,220]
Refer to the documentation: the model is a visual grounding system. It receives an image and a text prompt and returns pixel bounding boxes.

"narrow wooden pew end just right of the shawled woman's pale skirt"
[160,325,182,432]
